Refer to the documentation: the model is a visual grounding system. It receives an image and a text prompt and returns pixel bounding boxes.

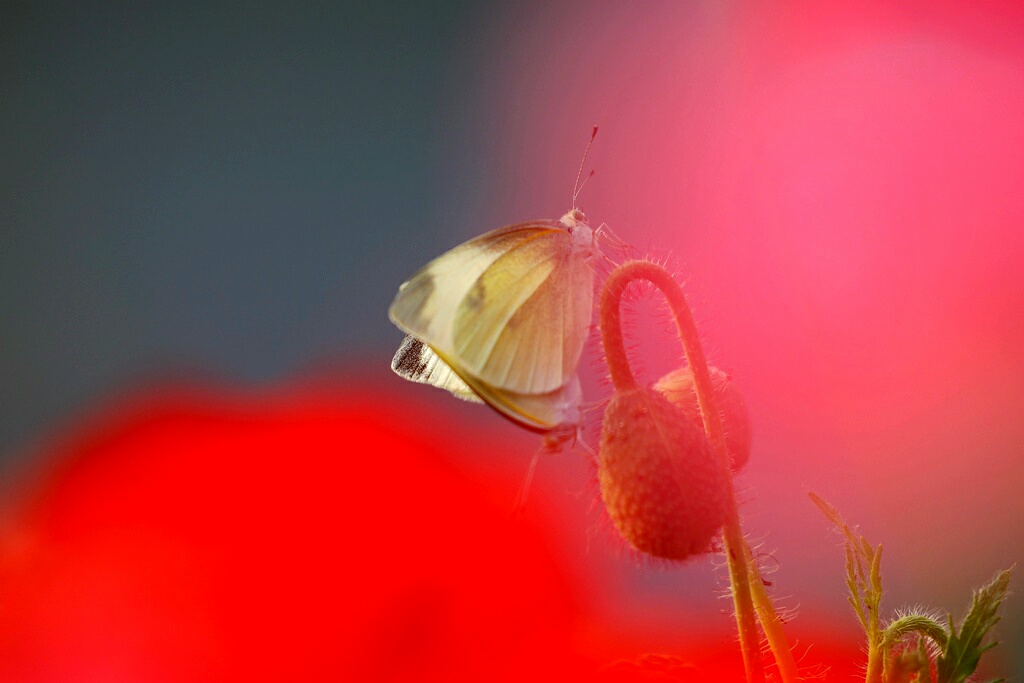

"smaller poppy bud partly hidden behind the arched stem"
[654,366,751,472]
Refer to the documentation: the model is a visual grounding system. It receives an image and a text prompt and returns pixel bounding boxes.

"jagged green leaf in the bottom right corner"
[936,569,1010,683]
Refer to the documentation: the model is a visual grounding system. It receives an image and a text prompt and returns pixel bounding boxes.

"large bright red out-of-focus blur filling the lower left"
[0,381,858,681]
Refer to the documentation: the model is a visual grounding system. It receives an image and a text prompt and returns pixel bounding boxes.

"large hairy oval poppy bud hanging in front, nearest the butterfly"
[597,385,730,560]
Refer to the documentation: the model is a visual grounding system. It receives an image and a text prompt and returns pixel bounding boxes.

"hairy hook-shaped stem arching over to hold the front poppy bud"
[600,261,765,683]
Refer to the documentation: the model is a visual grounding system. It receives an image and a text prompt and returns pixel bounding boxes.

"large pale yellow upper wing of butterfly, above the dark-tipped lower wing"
[389,220,594,394]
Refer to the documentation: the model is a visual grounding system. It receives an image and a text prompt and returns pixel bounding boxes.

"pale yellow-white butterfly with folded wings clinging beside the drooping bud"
[388,129,603,442]
